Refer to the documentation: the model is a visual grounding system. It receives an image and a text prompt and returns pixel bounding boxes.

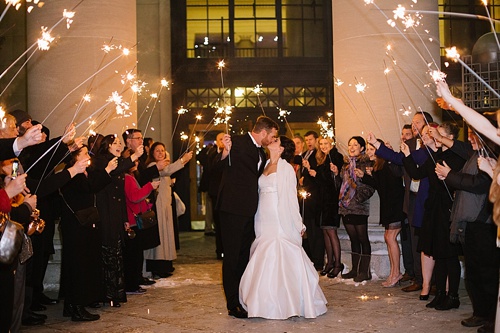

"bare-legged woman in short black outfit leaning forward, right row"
[361,143,406,288]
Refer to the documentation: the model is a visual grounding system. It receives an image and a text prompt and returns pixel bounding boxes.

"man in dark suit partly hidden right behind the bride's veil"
[299,131,325,270]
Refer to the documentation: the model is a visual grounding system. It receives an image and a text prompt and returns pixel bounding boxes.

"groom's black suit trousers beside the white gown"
[220,212,255,309]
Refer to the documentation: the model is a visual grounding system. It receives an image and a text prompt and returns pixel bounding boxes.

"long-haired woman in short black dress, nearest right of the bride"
[309,138,344,278]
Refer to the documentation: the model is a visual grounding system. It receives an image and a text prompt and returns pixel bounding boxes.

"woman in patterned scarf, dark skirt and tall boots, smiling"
[332,136,375,282]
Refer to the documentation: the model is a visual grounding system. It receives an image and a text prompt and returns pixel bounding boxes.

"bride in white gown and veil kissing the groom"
[239,136,327,319]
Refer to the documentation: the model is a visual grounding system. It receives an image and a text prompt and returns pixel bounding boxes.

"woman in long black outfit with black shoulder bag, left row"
[61,147,117,321]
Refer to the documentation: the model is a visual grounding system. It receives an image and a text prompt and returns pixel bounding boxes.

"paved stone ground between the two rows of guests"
[23,232,476,333]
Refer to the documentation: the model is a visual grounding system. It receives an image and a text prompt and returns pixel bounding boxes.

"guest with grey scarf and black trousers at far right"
[436,127,500,333]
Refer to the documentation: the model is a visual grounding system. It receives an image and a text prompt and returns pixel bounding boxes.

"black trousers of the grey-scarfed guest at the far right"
[463,222,500,320]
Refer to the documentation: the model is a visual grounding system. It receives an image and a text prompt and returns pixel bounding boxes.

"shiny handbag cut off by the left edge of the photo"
[0,213,24,265]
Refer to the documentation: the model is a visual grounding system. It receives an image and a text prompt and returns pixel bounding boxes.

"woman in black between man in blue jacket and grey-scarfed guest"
[401,123,468,310]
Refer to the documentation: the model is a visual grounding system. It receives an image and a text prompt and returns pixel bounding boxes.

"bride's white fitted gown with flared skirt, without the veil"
[239,170,327,319]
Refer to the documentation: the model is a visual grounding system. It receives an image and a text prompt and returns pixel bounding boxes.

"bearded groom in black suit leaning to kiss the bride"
[217,116,279,318]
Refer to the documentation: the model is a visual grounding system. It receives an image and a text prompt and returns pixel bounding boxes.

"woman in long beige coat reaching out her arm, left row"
[144,142,193,278]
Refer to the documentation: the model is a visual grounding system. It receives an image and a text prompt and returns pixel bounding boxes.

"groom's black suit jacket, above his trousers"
[217,134,266,217]
